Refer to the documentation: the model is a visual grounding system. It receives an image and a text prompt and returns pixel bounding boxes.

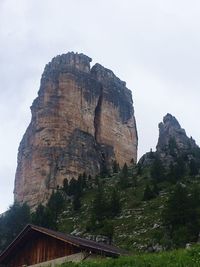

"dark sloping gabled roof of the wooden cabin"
[0,224,123,264]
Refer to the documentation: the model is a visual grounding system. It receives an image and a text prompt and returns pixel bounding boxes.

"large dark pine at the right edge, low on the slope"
[163,184,200,246]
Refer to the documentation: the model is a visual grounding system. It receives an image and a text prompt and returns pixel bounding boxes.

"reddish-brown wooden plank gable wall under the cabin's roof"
[5,233,80,267]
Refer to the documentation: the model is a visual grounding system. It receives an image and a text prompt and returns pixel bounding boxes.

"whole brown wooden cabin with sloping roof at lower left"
[0,224,121,267]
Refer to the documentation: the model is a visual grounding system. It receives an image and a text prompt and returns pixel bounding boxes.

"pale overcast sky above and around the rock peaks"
[0,0,200,212]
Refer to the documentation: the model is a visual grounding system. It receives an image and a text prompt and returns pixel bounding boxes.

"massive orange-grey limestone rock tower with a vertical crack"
[14,52,137,207]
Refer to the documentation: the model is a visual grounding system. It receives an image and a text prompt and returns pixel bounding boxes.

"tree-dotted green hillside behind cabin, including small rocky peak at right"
[0,115,200,258]
